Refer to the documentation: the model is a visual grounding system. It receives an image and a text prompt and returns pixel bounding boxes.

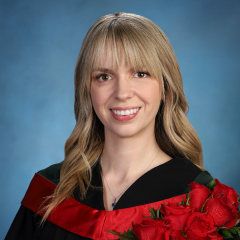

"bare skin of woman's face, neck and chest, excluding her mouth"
[91,46,171,211]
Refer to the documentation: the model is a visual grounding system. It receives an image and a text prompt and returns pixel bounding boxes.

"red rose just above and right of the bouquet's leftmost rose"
[160,204,194,230]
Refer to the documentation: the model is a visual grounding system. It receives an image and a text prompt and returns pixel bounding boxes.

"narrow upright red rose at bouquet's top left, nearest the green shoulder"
[189,182,212,212]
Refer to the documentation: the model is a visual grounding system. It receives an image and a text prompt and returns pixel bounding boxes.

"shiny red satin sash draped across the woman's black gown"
[21,173,185,240]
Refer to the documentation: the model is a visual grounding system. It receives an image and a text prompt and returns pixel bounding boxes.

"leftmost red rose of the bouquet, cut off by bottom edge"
[133,219,169,240]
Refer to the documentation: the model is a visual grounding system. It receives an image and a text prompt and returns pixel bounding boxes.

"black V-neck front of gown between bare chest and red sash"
[77,156,202,211]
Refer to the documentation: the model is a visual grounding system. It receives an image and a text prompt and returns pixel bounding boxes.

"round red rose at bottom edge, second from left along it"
[184,212,217,240]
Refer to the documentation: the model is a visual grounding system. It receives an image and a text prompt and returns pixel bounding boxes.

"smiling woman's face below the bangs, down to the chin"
[91,47,163,137]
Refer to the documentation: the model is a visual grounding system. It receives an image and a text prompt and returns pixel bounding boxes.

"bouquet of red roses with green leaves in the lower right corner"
[108,179,240,240]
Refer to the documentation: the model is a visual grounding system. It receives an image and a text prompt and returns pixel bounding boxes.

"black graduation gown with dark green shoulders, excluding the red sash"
[5,157,240,240]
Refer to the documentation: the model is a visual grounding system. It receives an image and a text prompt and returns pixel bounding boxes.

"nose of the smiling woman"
[114,74,134,101]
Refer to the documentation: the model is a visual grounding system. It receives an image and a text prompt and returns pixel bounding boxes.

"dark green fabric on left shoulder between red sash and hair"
[37,161,63,185]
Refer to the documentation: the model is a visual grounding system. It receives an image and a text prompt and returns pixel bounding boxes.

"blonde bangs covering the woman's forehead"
[87,21,162,81]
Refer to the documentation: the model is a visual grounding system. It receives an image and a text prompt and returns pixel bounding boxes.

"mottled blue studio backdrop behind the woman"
[0,0,240,239]
